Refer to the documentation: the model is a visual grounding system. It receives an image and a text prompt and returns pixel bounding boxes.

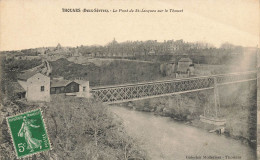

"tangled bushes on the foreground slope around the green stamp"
[0,96,146,160]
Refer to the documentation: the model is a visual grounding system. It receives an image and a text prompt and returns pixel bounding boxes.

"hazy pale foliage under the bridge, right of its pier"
[220,81,257,144]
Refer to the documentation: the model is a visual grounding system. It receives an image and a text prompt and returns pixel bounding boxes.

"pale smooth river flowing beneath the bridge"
[110,106,256,160]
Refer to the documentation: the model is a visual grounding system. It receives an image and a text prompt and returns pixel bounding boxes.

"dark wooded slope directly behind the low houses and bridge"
[51,59,161,86]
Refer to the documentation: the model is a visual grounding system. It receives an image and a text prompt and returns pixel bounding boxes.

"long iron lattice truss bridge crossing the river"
[91,71,257,103]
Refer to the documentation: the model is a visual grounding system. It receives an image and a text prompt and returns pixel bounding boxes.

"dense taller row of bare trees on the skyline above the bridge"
[76,39,243,57]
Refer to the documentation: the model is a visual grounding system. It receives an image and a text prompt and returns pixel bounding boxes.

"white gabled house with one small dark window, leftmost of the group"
[17,71,50,102]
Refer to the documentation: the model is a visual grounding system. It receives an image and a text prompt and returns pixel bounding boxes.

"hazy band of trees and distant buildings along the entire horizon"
[0,39,250,65]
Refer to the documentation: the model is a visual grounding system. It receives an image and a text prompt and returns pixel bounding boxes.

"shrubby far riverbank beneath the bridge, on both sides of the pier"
[121,83,256,148]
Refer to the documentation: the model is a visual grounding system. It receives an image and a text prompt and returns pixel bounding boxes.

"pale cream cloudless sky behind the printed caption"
[0,0,260,51]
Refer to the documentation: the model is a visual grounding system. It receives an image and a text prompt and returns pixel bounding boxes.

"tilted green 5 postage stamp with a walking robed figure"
[7,109,51,158]
